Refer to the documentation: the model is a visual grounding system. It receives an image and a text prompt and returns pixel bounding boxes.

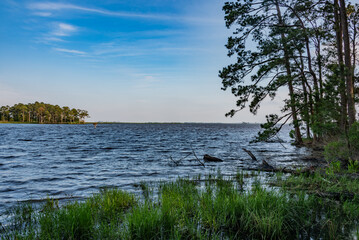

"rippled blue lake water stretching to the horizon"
[0,124,316,214]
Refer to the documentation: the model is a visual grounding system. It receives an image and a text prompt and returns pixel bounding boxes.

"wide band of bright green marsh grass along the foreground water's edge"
[2,173,359,239]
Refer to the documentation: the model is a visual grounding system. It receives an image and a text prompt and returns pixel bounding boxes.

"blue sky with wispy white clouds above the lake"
[0,0,286,123]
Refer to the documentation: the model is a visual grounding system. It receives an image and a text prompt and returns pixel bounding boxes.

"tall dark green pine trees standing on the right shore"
[219,0,359,144]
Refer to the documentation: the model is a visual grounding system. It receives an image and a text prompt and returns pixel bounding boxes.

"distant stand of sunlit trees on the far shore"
[0,102,89,123]
